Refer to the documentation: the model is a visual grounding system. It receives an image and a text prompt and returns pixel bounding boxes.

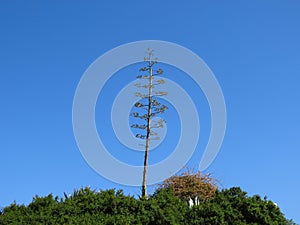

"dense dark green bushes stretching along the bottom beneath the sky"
[0,188,294,225]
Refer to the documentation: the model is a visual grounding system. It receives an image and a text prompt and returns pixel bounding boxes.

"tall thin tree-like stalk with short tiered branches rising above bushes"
[131,49,168,197]
